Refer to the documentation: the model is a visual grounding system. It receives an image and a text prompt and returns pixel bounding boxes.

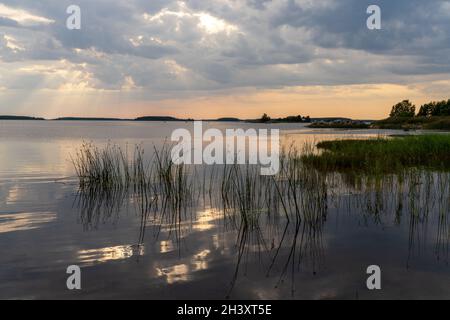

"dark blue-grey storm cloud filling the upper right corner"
[270,0,450,55]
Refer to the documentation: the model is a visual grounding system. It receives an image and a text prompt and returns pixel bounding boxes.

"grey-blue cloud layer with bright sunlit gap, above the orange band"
[0,0,450,117]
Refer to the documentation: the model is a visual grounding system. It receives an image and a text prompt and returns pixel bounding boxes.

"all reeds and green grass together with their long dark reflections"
[73,139,450,293]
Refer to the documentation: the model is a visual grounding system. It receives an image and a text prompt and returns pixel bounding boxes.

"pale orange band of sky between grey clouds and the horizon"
[17,81,450,119]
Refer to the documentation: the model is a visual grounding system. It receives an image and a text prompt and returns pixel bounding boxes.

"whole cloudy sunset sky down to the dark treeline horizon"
[0,0,450,119]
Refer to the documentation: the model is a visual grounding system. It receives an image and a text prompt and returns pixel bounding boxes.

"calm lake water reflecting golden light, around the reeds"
[0,121,450,299]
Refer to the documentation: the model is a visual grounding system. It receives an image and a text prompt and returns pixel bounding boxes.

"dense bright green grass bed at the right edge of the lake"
[302,135,450,173]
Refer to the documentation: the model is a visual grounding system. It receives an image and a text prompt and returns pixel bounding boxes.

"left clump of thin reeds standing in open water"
[72,143,192,236]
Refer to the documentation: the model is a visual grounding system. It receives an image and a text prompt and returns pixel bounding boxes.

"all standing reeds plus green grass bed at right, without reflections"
[73,135,450,229]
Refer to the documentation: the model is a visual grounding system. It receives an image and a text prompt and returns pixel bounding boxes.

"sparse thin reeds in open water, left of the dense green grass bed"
[72,143,326,230]
